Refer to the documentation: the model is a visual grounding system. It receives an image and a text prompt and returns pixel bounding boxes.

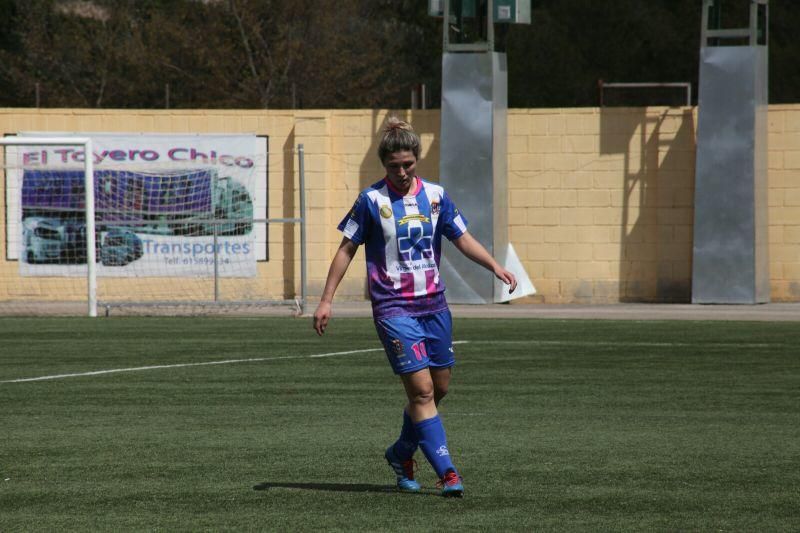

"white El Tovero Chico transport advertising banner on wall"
[7,133,267,277]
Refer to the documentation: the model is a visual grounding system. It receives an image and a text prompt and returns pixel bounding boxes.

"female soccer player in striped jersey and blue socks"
[314,117,517,497]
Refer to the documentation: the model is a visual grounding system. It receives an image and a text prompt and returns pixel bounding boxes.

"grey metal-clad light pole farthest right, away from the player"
[691,0,770,304]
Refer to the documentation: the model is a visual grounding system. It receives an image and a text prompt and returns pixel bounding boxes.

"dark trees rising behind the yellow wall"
[0,0,800,108]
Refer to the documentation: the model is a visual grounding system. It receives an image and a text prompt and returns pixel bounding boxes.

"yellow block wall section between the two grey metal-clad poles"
[508,108,695,303]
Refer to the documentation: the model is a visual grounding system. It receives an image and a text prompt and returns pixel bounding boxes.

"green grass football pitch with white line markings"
[0,318,800,532]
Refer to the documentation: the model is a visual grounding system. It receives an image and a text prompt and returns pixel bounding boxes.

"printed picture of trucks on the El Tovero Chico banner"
[22,168,253,266]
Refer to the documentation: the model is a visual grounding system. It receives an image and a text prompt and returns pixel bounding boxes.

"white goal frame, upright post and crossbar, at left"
[0,136,97,317]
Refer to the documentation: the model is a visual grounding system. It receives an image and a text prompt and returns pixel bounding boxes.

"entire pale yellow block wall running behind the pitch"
[0,105,800,303]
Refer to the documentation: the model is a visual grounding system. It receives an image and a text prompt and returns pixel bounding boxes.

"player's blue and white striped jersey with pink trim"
[339,177,467,318]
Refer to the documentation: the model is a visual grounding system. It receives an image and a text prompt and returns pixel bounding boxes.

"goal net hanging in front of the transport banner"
[3,134,301,314]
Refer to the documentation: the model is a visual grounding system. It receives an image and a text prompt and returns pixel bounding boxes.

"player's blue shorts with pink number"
[375,309,456,374]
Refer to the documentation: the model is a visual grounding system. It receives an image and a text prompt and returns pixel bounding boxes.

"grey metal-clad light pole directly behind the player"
[428,0,535,304]
